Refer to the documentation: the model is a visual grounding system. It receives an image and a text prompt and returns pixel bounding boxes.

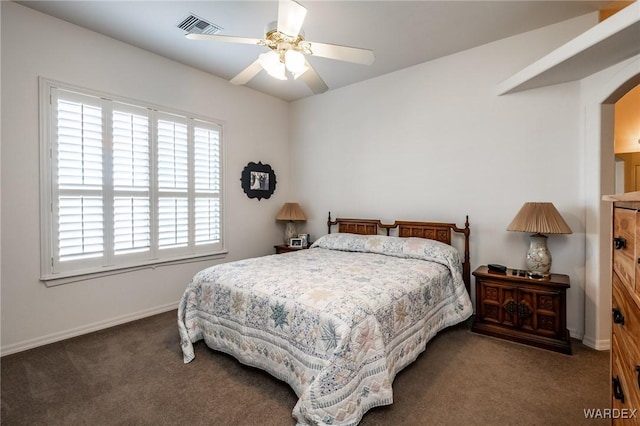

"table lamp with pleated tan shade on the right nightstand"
[507,203,572,278]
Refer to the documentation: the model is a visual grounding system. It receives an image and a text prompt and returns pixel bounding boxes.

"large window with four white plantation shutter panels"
[41,80,223,281]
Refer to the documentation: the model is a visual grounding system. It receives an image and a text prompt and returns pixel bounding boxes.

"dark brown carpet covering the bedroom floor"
[0,311,610,426]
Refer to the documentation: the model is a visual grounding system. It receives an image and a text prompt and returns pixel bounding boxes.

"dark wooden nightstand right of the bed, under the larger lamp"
[471,266,571,355]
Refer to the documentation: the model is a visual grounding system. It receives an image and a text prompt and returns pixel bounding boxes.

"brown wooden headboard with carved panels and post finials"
[327,212,471,292]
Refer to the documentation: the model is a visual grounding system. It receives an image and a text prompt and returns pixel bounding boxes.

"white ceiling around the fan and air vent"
[17,0,624,101]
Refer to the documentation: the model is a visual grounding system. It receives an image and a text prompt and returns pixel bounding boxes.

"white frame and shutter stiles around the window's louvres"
[39,77,227,286]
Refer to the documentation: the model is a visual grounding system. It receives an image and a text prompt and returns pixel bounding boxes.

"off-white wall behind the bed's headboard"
[291,15,596,338]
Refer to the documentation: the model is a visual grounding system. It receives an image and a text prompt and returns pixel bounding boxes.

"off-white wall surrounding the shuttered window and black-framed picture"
[0,2,291,354]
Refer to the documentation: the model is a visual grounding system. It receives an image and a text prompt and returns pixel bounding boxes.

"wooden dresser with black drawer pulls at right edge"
[605,193,640,424]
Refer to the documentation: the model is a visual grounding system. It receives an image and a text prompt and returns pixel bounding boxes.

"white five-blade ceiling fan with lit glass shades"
[185,0,375,94]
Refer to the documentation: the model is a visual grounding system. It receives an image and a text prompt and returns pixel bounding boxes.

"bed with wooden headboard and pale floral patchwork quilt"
[178,214,472,425]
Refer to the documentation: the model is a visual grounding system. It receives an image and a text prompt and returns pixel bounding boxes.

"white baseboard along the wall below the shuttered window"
[0,302,179,356]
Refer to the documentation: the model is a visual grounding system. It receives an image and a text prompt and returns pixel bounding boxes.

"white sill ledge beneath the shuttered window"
[40,250,228,287]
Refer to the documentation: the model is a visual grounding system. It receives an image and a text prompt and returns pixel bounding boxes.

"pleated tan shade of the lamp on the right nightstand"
[507,203,572,234]
